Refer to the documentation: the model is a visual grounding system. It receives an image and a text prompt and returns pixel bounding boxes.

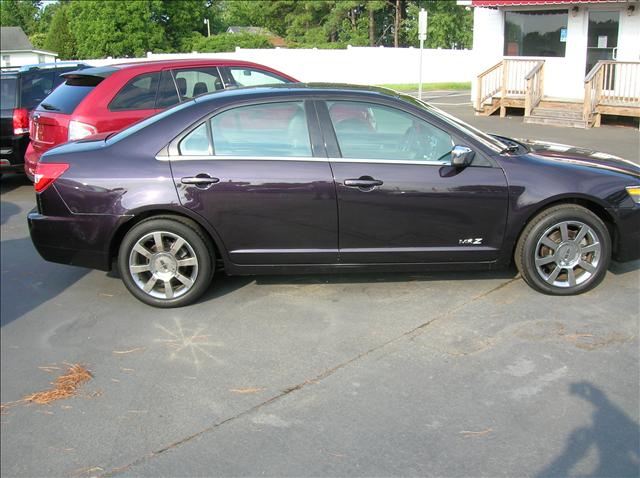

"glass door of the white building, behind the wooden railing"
[585,11,620,76]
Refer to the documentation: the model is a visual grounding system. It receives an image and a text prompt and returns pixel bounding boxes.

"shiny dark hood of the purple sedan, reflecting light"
[517,139,640,178]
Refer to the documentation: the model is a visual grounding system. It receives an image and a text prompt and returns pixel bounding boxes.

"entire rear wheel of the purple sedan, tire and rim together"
[118,216,215,308]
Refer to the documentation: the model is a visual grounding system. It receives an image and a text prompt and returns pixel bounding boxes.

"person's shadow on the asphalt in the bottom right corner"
[537,382,640,478]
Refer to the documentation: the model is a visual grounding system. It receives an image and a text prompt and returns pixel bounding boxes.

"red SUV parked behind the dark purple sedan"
[25,60,296,180]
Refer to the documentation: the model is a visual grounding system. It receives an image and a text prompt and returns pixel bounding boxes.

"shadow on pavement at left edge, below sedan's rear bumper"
[0,237,90,327]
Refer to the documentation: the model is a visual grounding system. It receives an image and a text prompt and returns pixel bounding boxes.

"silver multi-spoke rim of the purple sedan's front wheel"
[535,221,601,287]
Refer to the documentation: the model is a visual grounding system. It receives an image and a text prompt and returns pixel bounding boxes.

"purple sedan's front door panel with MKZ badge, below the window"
[331,162,507,263]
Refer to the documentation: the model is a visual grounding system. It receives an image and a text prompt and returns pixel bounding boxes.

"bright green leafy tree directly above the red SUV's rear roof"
[66,0,171,58]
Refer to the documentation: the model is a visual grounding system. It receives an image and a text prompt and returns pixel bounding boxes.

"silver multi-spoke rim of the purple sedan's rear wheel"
[129,231,198,299]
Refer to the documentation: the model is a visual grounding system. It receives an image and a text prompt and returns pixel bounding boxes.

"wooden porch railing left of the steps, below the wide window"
[475,58,544,116]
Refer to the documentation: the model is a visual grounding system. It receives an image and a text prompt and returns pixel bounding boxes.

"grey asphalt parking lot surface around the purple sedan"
[0,98,640,477]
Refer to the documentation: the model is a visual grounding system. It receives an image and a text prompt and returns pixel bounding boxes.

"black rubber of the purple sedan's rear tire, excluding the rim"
[118,219,215,308]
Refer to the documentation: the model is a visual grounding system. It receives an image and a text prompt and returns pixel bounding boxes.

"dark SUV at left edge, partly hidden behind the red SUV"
[0,62,86,173]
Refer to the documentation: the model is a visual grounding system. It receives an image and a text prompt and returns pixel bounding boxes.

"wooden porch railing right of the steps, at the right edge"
[583,60,640,122]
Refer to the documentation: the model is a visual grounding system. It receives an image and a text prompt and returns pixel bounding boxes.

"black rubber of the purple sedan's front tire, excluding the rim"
[521,207,611,295]
